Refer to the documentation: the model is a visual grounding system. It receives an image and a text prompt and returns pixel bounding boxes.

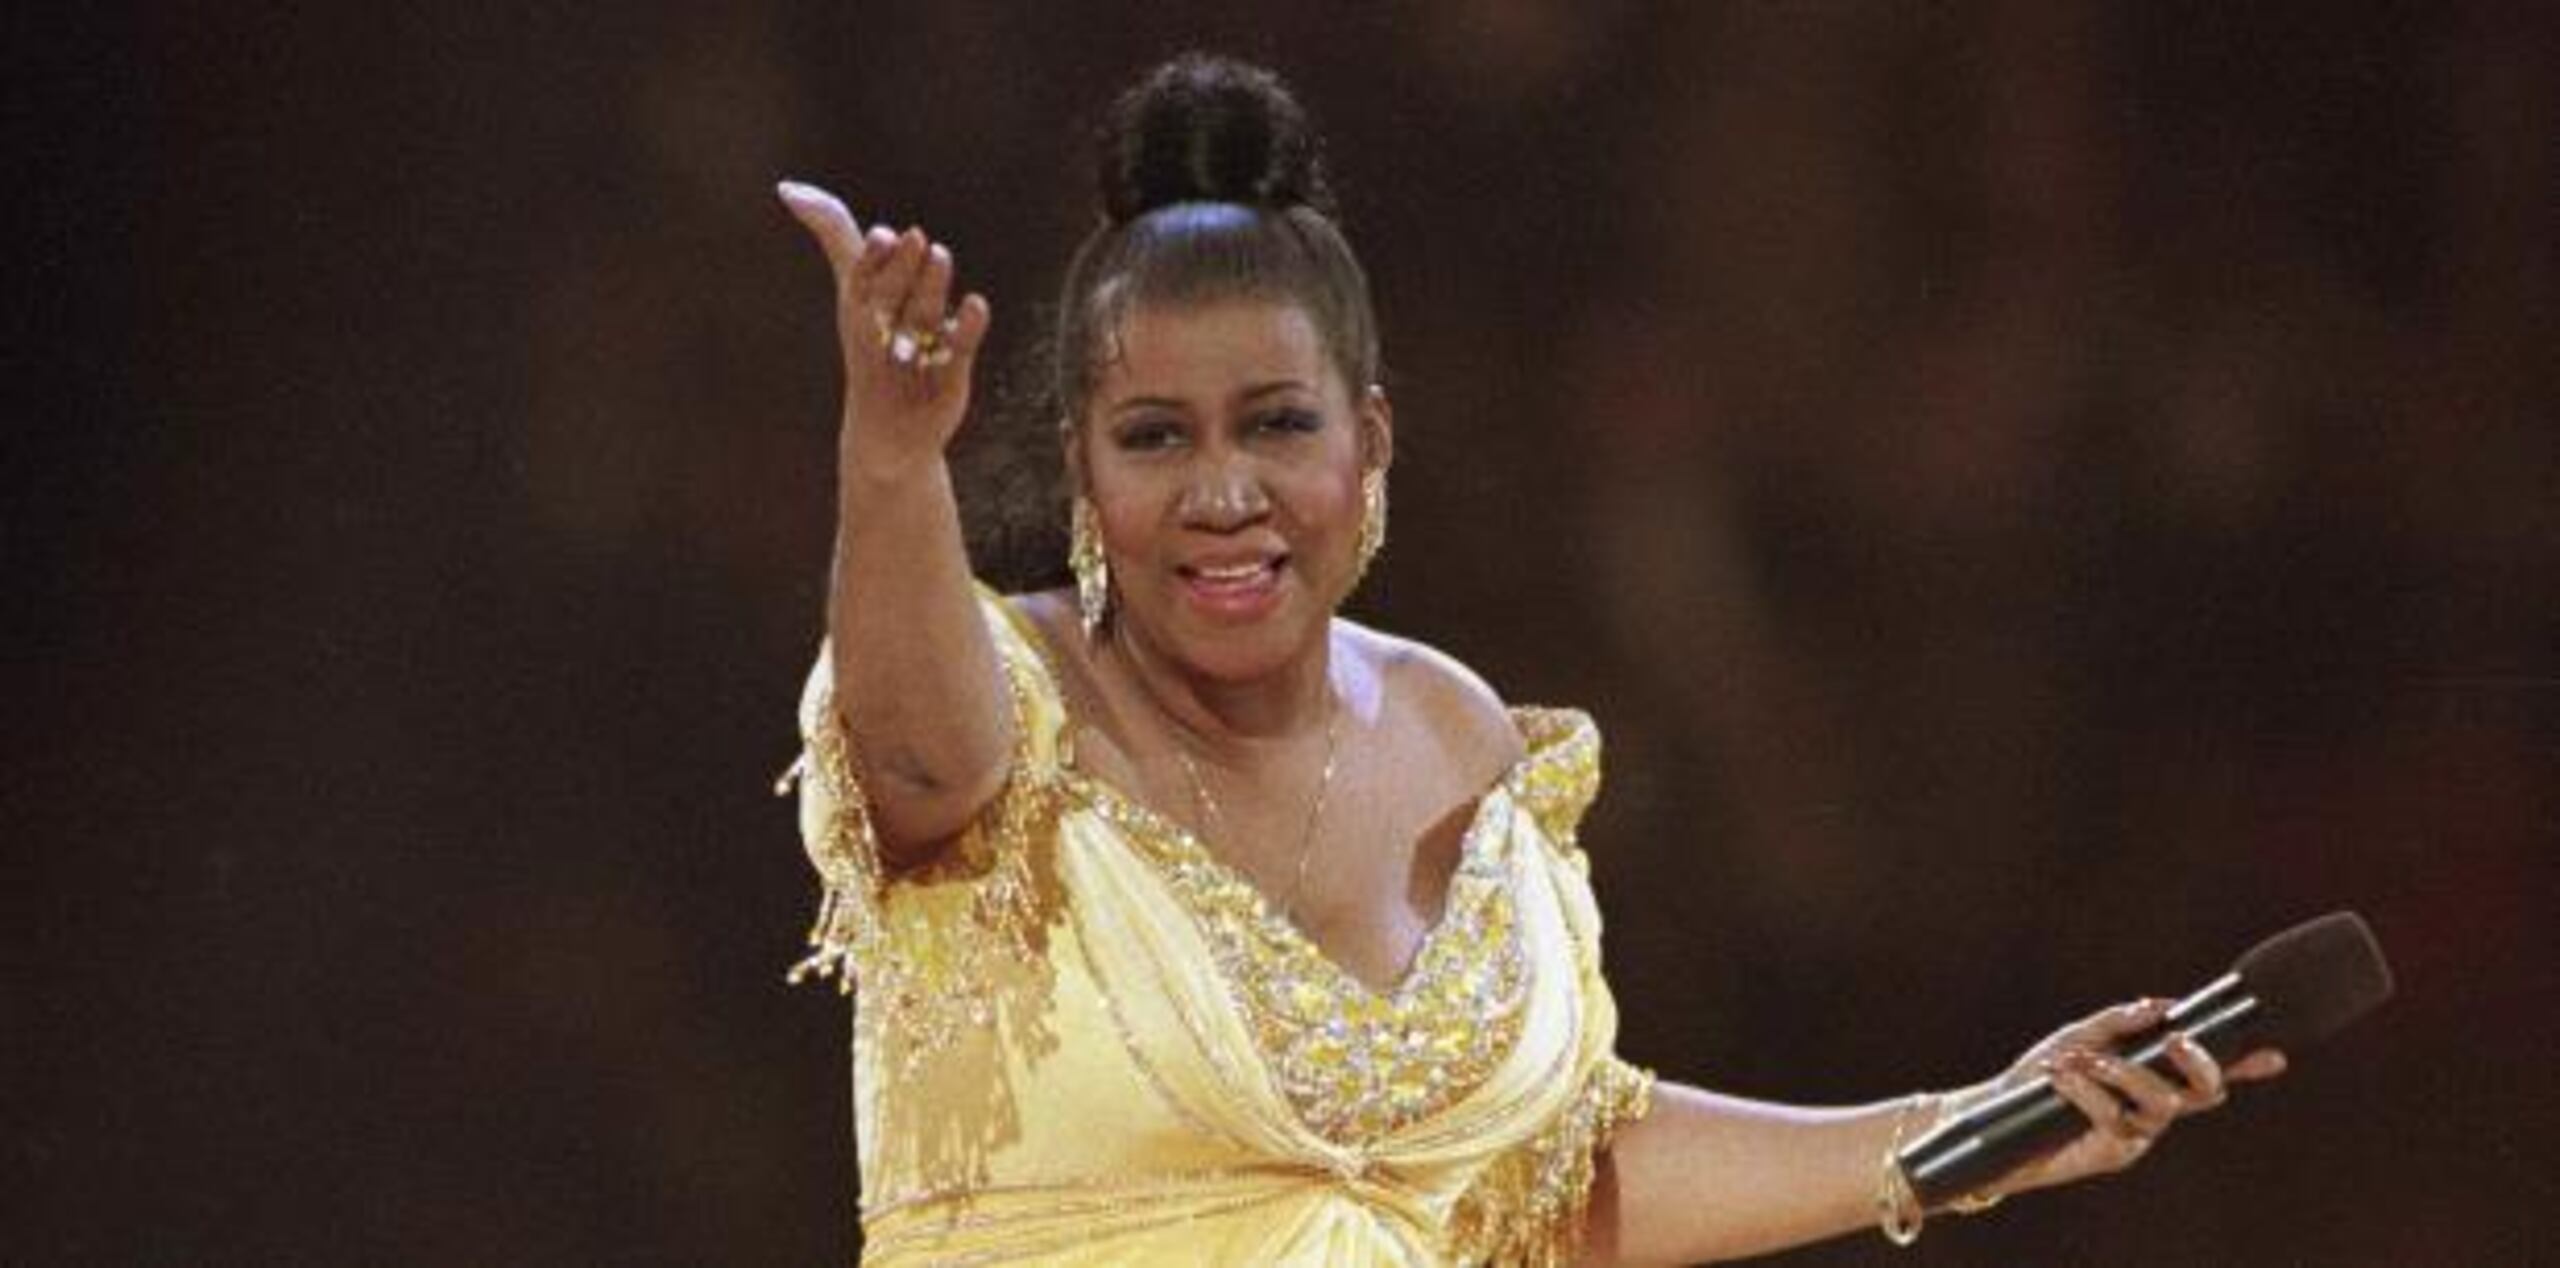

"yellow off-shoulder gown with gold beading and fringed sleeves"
[794,594,1651,1265]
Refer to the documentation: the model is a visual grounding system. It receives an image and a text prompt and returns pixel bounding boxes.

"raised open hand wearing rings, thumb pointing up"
[776,182,991,479]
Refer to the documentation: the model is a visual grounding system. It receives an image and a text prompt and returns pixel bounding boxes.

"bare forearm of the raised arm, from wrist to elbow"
[827,456,1011,858]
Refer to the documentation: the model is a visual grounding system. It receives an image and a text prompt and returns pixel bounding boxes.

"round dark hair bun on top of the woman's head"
[1098,54,1334,223]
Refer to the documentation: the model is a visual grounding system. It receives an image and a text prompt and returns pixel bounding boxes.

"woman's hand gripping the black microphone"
[1948,999,2284,1196]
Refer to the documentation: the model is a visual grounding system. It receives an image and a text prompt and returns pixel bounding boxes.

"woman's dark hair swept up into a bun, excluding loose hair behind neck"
[1050,54,1377,425]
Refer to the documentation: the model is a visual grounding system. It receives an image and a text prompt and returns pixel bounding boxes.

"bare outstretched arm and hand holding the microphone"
[1585,999,2284,1263]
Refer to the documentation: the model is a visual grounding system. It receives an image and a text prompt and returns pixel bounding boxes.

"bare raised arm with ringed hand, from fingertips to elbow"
[778,182,1011,863]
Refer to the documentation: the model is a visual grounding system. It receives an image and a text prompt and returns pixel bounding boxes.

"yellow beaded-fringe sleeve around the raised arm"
[776,587,1065,1053]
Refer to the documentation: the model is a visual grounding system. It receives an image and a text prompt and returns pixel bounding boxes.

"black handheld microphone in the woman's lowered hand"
[1894,912,2391,1209]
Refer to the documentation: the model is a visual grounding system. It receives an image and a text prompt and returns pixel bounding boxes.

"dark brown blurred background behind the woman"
[0,0,2560,1265]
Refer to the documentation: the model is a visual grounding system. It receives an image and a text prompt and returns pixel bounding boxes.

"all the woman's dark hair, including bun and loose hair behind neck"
[970,54,1382,587]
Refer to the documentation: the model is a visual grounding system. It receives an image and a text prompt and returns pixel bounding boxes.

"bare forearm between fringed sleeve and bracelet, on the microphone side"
[1587,1084,1976,1265]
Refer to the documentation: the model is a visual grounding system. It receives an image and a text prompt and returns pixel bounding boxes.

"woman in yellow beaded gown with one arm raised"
[781,56,2281,1263]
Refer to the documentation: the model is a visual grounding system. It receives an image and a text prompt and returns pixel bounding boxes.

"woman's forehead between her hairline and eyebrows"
[1098,300,1339,402]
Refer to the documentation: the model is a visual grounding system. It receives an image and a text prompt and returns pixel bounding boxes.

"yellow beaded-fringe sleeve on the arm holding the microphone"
[1449,710,1654,1268]
